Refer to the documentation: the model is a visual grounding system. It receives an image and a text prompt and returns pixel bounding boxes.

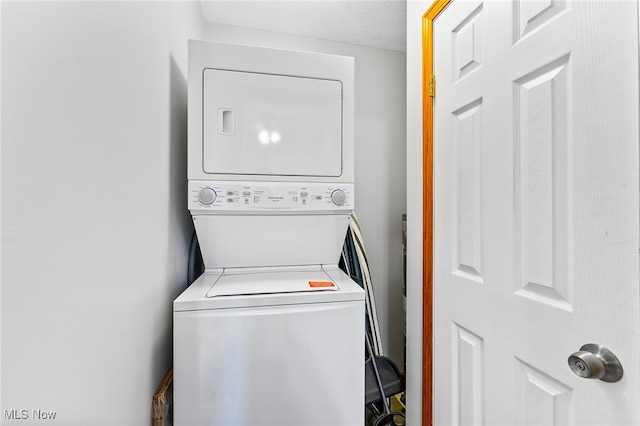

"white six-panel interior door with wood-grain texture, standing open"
[433,0,640,425]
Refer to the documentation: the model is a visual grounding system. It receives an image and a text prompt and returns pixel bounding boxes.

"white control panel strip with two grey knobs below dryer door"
[189,180,353,213]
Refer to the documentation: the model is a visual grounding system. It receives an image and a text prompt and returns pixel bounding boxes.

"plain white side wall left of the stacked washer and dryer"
[0,2,202,425]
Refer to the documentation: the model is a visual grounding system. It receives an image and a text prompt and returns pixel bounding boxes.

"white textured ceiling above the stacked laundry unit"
[200,0,407,52]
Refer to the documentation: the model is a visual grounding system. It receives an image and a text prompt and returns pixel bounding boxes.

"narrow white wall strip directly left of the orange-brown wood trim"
[407,0,431,425]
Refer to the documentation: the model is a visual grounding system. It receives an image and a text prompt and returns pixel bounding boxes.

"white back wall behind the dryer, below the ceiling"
[204,23,406,368]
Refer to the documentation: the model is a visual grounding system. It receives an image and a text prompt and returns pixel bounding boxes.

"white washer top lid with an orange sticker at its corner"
[207,270,340,297]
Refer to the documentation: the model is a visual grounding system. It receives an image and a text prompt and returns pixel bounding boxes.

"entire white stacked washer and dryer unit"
[173,40,365,426]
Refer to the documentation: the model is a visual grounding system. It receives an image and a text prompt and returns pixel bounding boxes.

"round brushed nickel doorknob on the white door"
[568,343,623,382]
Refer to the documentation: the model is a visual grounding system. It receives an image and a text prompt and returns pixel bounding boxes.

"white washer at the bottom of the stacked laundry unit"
[174,267,365,426]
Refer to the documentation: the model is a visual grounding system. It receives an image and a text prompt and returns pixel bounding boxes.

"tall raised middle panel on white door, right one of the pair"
[514,55,572,309]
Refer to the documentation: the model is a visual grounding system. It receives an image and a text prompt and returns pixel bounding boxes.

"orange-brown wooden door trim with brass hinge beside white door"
[422,0,451,426]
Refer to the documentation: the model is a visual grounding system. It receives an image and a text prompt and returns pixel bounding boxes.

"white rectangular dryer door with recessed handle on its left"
[202,68,342,177]
